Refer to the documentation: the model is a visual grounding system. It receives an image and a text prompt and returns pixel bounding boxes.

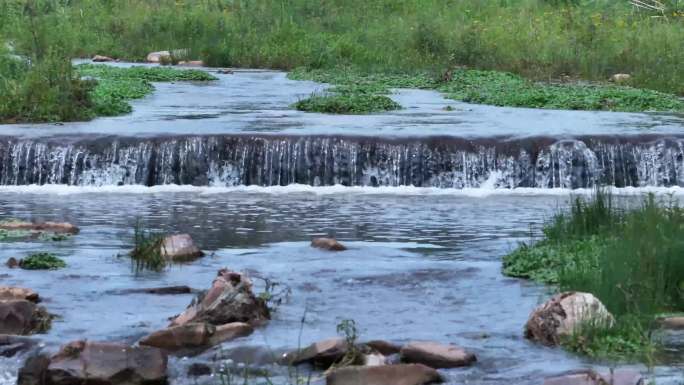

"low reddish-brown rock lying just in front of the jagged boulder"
[139,322,254,351]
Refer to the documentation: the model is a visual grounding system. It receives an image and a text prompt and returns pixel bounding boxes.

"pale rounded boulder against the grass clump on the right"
[525,292,614,346]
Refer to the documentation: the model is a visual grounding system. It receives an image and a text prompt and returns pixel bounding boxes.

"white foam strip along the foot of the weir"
[0,184,684,198]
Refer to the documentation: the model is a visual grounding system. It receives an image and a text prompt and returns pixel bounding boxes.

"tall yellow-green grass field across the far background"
[0,0,684,94]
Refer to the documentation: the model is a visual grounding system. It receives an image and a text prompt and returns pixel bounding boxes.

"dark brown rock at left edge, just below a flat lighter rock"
[0,300,52,335]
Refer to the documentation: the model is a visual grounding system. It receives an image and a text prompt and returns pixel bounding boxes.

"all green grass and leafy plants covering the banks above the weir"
[0,0,684,116]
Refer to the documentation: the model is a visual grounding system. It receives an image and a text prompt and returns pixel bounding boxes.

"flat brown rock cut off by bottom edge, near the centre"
[325,364,443,385]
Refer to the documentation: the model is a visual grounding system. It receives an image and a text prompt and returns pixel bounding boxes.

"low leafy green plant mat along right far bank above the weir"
[289,68,684,113]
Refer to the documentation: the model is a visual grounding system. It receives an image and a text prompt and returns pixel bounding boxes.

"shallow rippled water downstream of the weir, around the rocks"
[0,190,674,384]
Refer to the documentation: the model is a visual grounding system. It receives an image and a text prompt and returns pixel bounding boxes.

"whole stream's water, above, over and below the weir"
[0,63,684,384]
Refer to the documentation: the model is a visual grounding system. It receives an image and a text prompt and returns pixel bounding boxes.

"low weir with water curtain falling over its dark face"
[0,135,684,188]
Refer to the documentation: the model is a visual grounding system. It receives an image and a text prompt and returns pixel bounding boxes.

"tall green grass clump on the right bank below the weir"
[503,191,684,361]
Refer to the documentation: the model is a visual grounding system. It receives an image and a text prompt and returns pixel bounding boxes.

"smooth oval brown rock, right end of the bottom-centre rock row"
[400,341,477,369]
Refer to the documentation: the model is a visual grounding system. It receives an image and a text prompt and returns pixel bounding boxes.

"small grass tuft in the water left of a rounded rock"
[130,222,168,273]
